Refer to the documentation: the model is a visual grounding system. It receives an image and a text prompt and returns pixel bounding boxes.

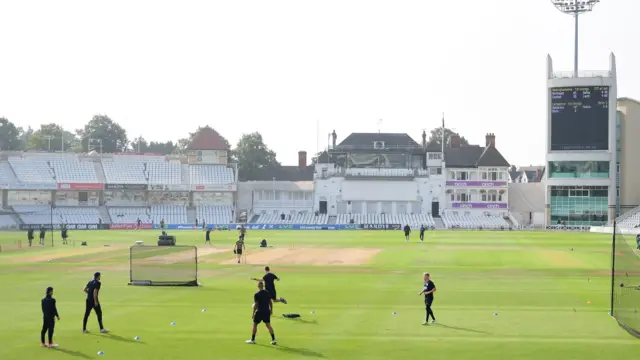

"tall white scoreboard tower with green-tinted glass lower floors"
[544,54,617,226]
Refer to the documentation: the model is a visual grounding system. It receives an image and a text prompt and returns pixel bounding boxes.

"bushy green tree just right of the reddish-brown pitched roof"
[232,132,280,179]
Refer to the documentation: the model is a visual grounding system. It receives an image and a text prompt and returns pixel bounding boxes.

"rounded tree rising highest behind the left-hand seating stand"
[76,115,129,153]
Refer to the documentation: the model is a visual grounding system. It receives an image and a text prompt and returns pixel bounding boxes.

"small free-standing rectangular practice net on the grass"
[129,245,198,286]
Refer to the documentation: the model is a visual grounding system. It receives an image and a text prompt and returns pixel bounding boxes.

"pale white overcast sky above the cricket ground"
[0,0,640,165]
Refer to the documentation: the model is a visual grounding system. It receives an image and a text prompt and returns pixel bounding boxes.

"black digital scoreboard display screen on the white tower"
[550,86,609,151]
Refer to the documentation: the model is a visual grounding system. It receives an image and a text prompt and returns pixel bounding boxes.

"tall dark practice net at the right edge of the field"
[611,223,640,337]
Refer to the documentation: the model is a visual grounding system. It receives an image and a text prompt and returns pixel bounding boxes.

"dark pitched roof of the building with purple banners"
[444,145,509,168]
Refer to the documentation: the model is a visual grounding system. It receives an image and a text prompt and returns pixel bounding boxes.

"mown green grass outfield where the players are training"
[0,231,640,360]
